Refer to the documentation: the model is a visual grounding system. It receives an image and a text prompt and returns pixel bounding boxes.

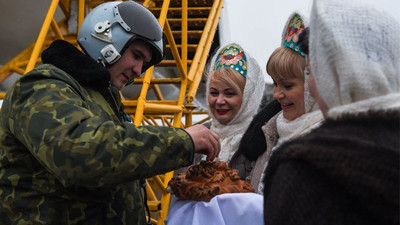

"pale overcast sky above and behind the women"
[219,0,400,82]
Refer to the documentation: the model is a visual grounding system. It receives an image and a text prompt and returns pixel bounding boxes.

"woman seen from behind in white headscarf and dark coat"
[264,0,400,225]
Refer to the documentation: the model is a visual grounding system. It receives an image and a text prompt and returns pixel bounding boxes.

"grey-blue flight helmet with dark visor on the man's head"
[78,1,164,72]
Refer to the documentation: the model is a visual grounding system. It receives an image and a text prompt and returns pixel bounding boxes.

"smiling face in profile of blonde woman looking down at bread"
[272,77,305,121]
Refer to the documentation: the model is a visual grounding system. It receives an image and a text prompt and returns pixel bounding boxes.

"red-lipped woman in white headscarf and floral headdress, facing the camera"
[206,43,265,165]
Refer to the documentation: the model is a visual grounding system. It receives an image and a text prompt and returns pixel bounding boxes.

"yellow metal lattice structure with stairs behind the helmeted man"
[0,0,223,224]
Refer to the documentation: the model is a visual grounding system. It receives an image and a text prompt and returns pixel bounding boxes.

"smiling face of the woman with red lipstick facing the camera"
[208,80,243,124]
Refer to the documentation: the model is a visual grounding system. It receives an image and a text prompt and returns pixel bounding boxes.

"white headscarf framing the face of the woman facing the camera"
[206,43,265,162]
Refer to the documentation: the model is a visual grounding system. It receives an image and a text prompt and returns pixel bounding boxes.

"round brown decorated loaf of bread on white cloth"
[168,161,254,202]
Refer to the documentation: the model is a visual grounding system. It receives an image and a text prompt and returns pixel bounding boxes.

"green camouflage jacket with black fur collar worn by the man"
[0,41,194,225]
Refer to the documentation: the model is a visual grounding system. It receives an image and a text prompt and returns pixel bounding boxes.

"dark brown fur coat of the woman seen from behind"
[263,110,400,225]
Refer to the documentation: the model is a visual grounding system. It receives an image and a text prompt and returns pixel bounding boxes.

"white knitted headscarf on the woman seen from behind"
[310,0,400,117]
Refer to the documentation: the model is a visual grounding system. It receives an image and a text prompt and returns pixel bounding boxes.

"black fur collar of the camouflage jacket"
[42,40,110,88]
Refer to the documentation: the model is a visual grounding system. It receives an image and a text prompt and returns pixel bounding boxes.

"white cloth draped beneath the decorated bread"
[165,193,264,225]
